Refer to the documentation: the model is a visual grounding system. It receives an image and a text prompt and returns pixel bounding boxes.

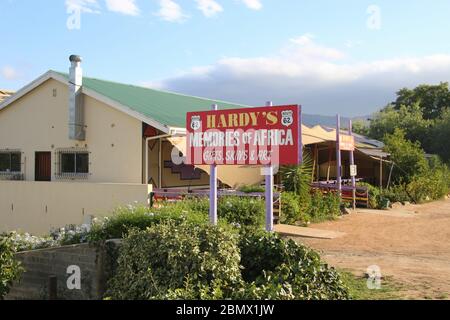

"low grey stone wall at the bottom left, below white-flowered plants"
[5,241,119,300]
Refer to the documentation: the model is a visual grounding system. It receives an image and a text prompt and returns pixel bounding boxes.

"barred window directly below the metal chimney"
[58,150,89,178]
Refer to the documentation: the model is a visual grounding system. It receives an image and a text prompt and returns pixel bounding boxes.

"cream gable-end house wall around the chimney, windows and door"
[0,79,142,183]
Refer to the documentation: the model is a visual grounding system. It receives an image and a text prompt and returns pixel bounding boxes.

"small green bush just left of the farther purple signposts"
[308,192,341,223]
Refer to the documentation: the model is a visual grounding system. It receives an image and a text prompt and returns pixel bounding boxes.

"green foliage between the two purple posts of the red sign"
[217,196,265,227]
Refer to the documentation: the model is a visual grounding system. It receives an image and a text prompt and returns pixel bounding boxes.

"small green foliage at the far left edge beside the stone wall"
[0,235,23,300]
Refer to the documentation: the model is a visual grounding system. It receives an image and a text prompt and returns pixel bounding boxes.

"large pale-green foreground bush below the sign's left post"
[107,222,241,300]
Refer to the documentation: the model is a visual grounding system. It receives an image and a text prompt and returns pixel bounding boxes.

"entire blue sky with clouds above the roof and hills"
[0,0,450,116]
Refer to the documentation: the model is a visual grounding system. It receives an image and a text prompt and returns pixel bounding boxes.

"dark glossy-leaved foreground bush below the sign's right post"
[239,232,349,300]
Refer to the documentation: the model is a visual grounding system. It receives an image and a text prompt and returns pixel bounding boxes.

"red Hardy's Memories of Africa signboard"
[186,105,301,165]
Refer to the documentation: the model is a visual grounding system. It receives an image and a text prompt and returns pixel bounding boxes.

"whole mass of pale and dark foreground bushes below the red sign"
[108,222,349,300]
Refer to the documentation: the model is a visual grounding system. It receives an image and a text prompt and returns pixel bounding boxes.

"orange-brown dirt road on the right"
[296,200,450,299]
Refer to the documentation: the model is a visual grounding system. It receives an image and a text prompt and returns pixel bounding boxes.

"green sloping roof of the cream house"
[57,72,249,128]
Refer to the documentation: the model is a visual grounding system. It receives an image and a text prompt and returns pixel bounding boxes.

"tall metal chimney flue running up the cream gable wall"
[69,55,86,141]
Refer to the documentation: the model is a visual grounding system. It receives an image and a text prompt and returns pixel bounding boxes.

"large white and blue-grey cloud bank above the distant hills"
[149,35,450,115]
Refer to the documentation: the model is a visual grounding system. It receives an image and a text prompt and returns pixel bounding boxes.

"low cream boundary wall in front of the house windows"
[0,181,151,235]
